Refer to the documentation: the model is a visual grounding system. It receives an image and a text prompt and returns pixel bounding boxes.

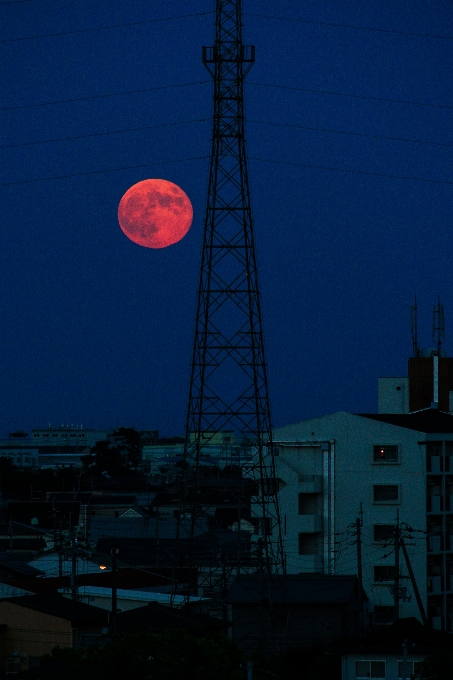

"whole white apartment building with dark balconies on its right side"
[274,408,453,631]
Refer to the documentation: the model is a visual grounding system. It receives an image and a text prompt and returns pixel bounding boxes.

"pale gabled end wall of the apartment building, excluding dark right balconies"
[274,413,427,618]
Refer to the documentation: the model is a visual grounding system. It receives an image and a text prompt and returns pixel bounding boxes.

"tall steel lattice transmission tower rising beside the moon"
[172,0,284,644]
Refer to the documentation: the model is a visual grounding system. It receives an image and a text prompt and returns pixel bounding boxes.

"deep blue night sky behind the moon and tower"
[0,0,453,435]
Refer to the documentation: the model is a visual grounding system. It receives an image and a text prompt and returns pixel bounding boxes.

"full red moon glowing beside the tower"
[118,179,193,248]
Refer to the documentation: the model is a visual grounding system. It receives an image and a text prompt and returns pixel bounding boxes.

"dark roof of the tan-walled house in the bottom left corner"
[0,593,108,627]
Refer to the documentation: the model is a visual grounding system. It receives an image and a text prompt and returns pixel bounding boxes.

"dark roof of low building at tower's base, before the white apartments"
[227,574,368,605]
